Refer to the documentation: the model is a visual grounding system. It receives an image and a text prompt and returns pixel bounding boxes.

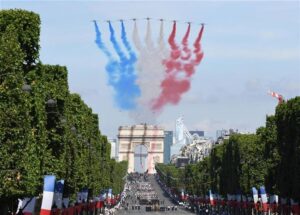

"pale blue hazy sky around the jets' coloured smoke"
[0,0,300,138]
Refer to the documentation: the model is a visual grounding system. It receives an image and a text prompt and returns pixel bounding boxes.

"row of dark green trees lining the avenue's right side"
[156,97,300,201]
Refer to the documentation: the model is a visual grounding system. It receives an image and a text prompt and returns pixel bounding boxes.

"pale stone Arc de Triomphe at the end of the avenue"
[118,124,164,174]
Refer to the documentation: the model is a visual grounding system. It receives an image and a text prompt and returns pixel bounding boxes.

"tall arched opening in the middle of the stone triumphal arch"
[134,145,148,173]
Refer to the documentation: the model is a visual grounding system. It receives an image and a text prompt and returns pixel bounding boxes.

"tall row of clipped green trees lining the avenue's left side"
[0,10,127,205]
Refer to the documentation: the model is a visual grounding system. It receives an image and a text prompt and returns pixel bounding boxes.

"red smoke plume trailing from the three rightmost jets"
[152,22,204,111]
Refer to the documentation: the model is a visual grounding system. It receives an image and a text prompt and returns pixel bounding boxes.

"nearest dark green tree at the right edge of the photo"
[275,97,300,201]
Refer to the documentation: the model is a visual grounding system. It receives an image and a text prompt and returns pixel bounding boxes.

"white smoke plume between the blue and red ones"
[133,20,167,122]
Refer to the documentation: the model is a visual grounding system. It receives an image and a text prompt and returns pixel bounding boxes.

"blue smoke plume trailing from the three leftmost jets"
[94,21,140,110]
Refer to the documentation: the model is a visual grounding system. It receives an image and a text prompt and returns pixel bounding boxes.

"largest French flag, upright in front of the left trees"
[40,175,55,215]
